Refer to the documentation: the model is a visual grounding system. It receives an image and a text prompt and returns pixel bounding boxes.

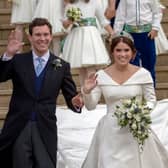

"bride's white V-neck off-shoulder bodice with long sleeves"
[85,68,156,113]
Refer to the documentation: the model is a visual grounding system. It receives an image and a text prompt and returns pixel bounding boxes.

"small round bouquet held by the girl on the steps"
[66,7,82,23]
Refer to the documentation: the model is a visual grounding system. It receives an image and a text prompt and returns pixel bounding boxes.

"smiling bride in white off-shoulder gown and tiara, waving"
[82,33,168,168]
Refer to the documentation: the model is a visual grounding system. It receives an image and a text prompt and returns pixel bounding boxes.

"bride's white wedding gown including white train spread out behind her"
[57,68,168,168]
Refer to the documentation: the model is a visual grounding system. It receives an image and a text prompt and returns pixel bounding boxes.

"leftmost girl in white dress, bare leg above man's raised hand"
[11,0,36,50]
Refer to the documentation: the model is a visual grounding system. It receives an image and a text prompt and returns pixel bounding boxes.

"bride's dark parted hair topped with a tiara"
[110,31,136,54]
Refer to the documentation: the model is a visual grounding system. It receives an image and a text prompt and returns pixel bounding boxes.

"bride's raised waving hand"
[83,73,97,94]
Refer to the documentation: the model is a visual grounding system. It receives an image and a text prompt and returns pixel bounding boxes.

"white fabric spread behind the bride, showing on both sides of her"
[57,99,168,168]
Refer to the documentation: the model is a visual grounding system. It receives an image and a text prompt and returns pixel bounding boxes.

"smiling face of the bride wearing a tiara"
[112,41,134,65]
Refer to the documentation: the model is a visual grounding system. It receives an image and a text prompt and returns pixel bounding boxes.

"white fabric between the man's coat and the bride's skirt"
[56,105,106,168]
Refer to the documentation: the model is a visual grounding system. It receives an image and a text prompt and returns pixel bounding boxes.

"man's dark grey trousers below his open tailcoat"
[13,121,55,168]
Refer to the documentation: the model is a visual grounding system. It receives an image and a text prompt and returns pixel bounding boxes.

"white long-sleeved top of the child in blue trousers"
[114,0,160,31]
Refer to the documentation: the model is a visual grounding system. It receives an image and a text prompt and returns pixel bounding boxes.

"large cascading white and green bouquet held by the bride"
[114,97,152,150]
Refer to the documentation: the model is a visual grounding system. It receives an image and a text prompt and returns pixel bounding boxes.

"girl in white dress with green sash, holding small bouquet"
[62,0,113,84]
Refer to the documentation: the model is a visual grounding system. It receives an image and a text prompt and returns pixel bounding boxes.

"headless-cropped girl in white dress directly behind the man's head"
[34,0,64,56]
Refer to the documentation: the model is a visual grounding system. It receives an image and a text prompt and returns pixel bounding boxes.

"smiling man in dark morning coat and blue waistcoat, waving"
[0,18,83,168]
